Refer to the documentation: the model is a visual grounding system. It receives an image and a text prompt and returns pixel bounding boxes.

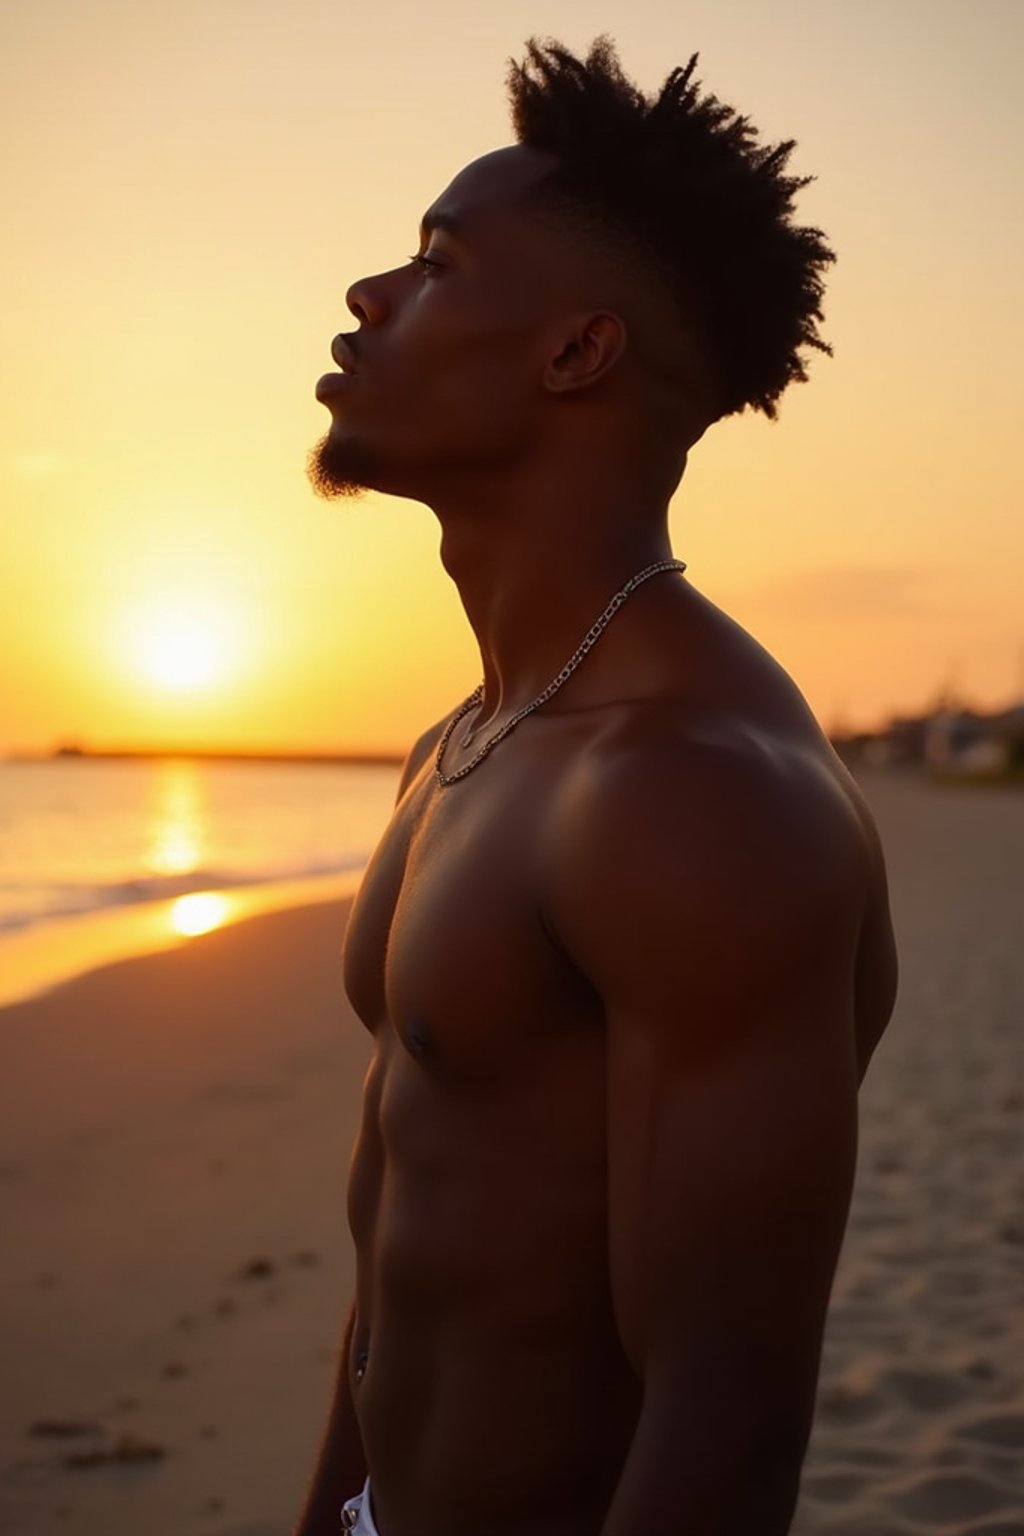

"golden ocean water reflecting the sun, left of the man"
[0,759,399,935]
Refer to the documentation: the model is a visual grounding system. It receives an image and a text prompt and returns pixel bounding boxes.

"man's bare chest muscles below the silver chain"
[344,755,592,1071]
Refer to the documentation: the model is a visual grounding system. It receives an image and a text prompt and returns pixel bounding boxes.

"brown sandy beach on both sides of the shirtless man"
[0,776,1024,1536]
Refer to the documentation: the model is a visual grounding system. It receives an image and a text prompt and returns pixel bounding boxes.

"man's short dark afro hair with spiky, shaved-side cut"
[508,37,835,416]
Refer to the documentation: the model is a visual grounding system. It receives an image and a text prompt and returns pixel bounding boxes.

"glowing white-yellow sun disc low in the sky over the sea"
[130,593,236,693]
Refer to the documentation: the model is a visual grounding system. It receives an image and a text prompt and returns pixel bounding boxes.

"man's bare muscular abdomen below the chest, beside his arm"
[348,1037,639,1536]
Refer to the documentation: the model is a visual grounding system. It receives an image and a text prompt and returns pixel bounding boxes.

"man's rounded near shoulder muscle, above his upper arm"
[539,703,878,1043]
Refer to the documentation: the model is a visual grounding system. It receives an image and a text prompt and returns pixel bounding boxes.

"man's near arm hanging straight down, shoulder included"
[545,742,866,1536]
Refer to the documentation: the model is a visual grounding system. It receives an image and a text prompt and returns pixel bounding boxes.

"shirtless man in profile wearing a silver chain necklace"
[296,41,895,1536]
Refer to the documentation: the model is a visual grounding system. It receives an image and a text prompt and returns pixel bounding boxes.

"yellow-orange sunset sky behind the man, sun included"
[0,0,1024,751]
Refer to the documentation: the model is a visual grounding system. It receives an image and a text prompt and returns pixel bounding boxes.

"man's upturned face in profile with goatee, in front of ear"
[310,147,568,499]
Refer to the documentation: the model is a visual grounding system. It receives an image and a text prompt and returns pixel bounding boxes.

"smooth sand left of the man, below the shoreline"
[0,902,367,1536]
